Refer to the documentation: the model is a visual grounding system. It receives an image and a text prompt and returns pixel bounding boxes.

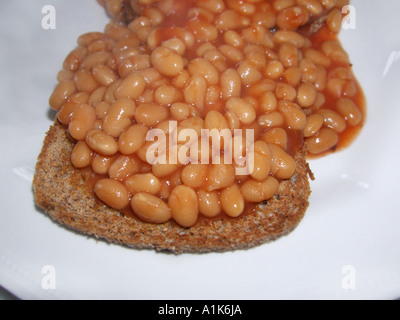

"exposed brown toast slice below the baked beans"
[33,120,311,254]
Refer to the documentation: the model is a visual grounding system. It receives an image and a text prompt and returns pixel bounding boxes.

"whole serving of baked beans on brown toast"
[33,0,365,253]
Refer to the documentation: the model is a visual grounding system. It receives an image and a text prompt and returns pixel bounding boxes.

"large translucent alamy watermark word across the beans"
[146,121,254,175]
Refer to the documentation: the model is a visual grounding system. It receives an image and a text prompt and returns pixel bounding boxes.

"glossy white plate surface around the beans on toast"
[0,0,400,299]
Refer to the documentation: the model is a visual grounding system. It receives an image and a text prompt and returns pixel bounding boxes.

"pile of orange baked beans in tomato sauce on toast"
[49,0,363,227]
